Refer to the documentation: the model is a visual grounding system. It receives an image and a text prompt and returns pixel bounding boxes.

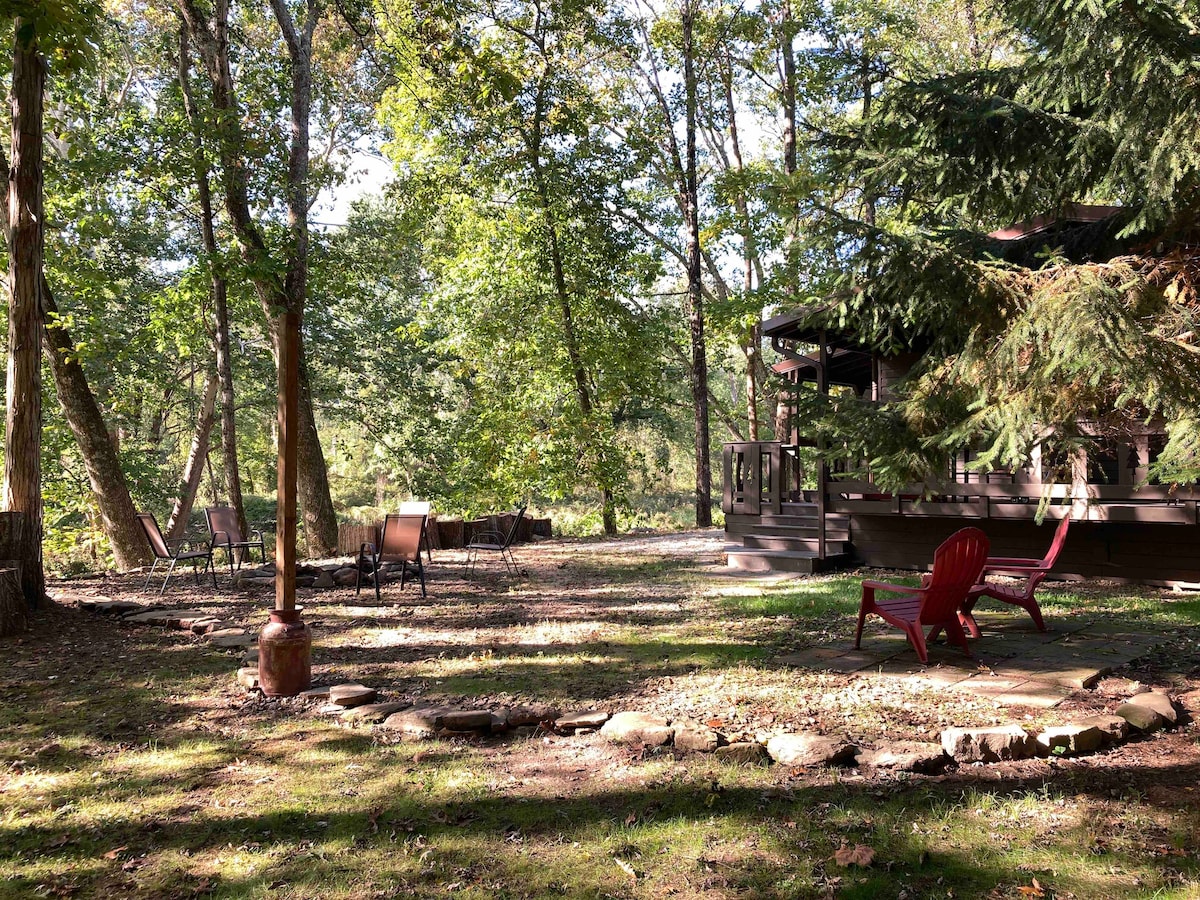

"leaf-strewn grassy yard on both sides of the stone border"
[0,532,1200,900]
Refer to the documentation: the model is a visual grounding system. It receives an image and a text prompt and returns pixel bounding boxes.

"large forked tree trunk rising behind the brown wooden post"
[176,0,337,556]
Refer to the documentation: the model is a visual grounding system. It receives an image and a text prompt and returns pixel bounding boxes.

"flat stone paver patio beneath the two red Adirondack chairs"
[776,611,1163,709]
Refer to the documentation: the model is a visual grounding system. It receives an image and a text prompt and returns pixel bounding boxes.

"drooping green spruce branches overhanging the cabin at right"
[792,2,1200,487]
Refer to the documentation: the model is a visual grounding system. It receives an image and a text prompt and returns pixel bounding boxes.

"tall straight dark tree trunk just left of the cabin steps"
[683,0,713,528]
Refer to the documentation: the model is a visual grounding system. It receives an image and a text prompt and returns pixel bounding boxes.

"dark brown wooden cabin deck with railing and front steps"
[724,442,1200,587]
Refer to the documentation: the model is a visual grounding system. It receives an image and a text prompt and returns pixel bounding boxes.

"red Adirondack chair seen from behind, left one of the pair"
[854,528,989,662]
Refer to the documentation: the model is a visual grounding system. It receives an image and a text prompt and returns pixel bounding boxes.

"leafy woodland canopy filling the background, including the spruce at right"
[0,0,1200,566]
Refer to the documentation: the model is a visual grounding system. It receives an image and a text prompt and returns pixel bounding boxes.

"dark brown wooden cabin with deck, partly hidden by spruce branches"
[722,206,1200,586]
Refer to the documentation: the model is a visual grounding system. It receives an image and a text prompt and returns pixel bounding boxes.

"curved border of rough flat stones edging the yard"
[79,600,1200,773]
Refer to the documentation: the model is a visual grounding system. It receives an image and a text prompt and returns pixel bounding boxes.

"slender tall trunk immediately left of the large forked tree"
[179,24,250,547]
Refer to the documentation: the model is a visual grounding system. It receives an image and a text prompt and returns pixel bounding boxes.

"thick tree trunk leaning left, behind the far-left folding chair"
[42,280,149,570]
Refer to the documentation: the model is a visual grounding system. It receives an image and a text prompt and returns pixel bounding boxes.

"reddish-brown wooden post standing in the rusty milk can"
[275,310,300,610]
